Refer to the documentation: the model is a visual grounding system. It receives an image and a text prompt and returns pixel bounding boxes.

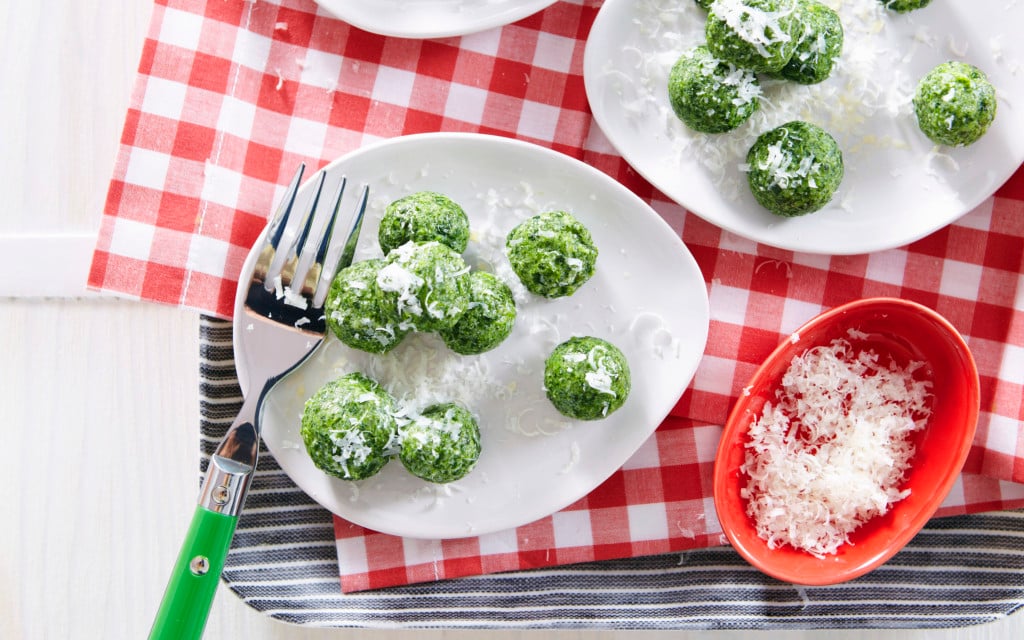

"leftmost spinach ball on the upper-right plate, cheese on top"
[669,45,761,133]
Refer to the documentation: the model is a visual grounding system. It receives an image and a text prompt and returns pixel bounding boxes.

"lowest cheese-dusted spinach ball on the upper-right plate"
[746,120,845,217]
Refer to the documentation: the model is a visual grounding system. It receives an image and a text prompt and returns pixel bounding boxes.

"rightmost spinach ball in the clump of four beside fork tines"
[440,271,516,355]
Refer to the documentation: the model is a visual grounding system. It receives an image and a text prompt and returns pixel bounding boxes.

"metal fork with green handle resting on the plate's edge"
[150,165,369,639]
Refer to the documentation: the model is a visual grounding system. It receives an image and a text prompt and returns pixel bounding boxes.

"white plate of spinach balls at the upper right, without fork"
[584,0,1024,254]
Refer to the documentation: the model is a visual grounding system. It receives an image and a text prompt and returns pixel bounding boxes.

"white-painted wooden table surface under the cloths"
[0,0,1024,640]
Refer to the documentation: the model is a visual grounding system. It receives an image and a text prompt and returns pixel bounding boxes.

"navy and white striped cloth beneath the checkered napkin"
[200,316,1024,630]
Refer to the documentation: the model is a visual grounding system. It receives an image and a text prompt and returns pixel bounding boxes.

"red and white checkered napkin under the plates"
[89,0,1024,591]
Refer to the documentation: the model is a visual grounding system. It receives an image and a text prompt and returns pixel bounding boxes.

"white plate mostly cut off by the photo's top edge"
[316,0,554,38]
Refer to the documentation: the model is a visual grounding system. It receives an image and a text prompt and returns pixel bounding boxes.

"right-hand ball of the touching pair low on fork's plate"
[398,402,481,483]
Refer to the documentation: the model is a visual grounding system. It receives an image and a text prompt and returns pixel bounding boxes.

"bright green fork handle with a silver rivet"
[150,505,239,640]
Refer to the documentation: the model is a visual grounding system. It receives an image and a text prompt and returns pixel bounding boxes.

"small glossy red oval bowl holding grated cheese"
[714,298,980,586]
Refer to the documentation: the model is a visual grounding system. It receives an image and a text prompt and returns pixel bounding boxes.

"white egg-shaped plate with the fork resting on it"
[236,133,709,539]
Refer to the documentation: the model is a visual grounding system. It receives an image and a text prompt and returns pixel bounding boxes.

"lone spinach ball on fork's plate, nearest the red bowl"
[544,336,631,420]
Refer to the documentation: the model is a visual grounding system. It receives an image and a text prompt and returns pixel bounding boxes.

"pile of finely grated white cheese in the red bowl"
[740,331,931,557]
